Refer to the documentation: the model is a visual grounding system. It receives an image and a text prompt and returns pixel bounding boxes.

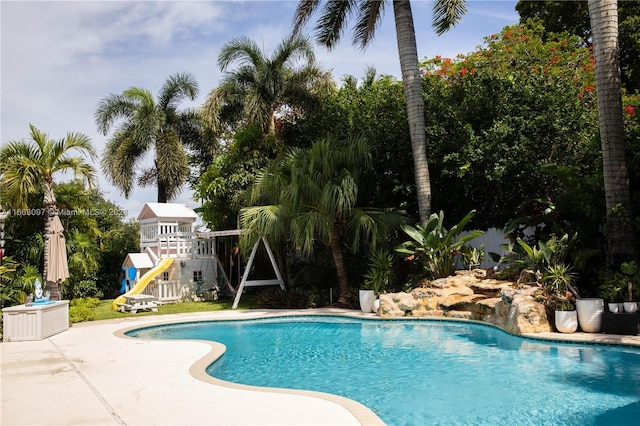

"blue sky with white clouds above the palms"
[0,0,519,218]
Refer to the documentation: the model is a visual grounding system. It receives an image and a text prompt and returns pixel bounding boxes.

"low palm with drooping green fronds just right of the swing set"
[240,135,403,304]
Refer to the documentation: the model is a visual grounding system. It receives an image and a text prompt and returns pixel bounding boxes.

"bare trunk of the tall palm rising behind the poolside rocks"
[393,0,431,226]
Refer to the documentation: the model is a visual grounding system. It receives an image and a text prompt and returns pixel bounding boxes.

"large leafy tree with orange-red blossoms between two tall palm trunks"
[421,26,602,230]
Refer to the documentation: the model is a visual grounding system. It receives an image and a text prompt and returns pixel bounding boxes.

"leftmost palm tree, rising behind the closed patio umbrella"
[0,124,96,300]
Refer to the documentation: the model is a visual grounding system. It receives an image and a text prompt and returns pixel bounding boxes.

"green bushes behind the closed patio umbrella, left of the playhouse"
[2,181,139,299]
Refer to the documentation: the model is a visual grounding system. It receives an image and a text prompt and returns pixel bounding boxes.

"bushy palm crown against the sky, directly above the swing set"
[204,36,331,135]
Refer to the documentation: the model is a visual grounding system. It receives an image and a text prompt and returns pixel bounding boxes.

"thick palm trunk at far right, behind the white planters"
[588,0,637,267]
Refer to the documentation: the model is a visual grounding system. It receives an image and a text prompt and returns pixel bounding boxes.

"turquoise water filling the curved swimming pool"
[128,316,640,426]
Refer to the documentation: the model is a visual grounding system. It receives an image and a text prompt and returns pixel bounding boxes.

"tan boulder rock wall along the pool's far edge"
[378,269,553,334]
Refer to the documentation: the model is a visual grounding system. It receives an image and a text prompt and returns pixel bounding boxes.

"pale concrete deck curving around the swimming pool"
[0,309,640,426]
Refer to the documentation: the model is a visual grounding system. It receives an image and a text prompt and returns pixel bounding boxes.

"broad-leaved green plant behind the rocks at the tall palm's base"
[395,210,484,279]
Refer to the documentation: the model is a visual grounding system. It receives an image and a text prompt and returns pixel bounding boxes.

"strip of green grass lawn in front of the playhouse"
[74,294,258,322]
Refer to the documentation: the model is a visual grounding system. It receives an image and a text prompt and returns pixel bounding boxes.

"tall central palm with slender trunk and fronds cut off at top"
[293,0,466,225]
